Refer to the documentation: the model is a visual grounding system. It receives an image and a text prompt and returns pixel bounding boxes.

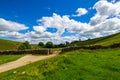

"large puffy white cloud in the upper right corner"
[90,0,120,26]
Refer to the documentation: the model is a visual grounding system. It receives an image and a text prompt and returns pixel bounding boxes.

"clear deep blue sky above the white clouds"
[0,0,98,26]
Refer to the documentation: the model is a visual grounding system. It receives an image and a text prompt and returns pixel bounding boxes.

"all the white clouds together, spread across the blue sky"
[0,0,120,44]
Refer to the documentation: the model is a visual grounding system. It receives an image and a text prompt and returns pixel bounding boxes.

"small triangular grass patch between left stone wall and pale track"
[0,55,24,65]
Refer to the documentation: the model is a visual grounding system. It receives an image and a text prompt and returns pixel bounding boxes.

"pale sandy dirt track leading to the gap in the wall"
[0,53,58,73]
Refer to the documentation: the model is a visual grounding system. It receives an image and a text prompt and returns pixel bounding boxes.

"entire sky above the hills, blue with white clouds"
[0,0,120,43]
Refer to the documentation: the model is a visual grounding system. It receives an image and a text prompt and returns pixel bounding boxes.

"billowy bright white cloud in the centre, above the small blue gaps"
[38,13,90,35]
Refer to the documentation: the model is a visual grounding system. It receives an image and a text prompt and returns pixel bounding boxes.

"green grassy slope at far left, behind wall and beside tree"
[0,39,21,50]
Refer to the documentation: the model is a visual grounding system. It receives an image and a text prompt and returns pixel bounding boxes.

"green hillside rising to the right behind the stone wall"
[71,33,120,46]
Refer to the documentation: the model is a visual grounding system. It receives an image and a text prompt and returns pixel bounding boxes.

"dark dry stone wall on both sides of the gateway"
[0,43,120,55]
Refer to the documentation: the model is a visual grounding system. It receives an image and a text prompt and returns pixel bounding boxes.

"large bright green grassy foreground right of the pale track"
[0,48,120,80]
